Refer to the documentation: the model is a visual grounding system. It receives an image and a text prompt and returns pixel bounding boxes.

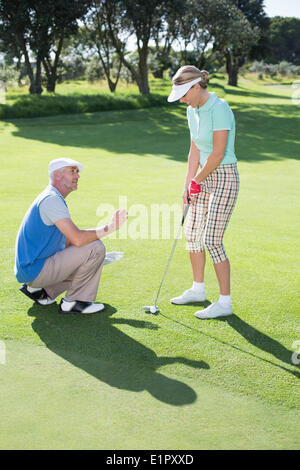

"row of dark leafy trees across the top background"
[0,0,300,94]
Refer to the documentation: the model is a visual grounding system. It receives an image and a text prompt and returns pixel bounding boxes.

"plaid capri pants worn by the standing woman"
[185,163,239,264]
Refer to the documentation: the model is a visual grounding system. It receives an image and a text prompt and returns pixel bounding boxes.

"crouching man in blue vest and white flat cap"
[15,158,127,314]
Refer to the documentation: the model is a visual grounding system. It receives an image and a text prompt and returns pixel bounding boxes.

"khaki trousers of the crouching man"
[28,240,105,302]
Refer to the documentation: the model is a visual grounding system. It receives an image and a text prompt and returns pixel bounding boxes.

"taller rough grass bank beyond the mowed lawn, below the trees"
[0,75,224,119]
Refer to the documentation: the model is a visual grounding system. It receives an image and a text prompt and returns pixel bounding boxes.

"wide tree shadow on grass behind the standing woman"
[6,101,300,162]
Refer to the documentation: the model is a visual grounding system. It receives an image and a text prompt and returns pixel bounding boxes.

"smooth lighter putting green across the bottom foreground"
[0,341,299,450]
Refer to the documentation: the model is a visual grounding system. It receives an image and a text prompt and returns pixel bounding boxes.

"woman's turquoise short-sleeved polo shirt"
[187,93,237,166]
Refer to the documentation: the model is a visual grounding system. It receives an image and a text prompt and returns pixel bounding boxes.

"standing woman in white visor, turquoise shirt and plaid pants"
[168,65,239,319]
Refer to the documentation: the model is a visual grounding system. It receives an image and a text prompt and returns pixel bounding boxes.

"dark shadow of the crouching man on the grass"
[28,304,209,406]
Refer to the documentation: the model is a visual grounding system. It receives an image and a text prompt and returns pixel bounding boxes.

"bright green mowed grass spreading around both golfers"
[0,75,300,449]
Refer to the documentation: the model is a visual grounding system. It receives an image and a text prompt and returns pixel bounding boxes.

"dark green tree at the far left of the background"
[0,0,89,94]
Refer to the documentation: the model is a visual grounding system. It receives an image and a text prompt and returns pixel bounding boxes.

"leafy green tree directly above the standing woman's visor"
[171,0,264,86]
